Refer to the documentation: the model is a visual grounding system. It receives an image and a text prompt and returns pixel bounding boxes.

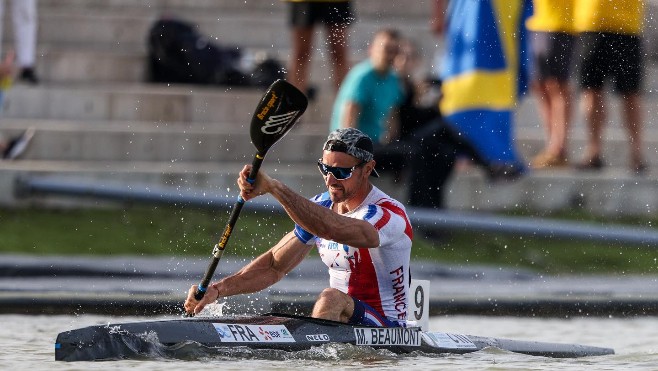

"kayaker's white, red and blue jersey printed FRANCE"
[295,187,413,325]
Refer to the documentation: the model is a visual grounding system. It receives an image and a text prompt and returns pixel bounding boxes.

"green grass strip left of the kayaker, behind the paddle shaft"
[0,206,292,255]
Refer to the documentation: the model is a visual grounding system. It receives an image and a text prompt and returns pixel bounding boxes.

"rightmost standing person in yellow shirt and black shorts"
[574,0,646,174]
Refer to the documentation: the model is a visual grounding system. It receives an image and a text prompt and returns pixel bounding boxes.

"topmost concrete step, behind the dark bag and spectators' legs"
[18,0,658,89]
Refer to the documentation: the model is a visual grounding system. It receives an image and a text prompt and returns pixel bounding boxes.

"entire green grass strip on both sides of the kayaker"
[0,206,658,274]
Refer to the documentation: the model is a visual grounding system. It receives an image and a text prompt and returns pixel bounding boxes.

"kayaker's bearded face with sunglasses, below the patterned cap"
[322,151,368,203]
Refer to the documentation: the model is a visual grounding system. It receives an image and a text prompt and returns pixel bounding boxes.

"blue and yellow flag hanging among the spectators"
[431,0,531,176]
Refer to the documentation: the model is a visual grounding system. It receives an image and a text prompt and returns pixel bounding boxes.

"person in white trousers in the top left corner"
[0,0,39,84]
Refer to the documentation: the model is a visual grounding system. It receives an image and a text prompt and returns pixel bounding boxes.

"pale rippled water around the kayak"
[0,315,658,371]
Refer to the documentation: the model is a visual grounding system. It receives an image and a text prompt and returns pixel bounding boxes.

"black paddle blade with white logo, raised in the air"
[250,80,308,156]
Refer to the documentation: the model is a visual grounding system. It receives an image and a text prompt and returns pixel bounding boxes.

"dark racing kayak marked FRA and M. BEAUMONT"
[55,313,614,361]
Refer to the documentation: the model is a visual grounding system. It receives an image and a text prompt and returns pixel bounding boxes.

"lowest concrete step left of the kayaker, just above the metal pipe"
[0,160,324,211]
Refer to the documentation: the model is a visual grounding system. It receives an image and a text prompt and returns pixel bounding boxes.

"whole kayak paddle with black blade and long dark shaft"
[194,80,308,300]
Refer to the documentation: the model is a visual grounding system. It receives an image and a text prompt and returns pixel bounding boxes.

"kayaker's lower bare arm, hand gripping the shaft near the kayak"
[184,232,311,313]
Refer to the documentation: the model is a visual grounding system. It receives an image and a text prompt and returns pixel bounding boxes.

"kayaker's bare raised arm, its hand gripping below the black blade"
[238,165,379,248]
